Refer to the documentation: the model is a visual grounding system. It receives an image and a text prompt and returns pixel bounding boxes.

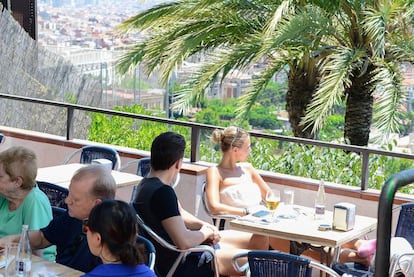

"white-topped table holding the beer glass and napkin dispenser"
[230,205,377,262]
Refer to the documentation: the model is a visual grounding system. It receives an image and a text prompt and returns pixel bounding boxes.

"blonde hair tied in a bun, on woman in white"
[211,126,249,152]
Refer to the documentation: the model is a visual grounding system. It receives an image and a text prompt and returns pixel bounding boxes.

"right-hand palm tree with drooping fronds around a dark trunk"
[303,0,414,145]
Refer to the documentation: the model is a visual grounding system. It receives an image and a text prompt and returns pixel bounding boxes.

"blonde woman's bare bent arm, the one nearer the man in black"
[205,167,246,216]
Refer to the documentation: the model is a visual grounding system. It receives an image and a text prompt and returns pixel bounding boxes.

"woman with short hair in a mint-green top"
[0,146,55,261]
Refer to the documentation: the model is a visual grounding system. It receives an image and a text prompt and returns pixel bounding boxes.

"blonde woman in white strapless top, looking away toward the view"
[205,126,289,251]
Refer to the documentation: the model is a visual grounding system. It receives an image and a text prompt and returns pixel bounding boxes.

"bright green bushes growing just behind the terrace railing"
[88,102,414,190]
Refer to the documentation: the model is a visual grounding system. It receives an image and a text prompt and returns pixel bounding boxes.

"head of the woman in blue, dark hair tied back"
[85,200,144,265]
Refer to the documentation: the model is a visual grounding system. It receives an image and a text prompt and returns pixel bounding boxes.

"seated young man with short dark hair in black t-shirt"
[133,132,240,277]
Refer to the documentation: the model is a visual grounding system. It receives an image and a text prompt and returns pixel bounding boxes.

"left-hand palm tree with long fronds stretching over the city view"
[118,0,329,138]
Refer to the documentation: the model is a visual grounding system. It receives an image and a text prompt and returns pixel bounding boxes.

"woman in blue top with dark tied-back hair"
[82,200,155,277]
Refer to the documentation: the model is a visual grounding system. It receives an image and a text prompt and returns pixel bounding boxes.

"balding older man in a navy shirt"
[0,165,116,272]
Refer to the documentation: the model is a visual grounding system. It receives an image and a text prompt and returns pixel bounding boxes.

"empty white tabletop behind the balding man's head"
[36,163,142,188]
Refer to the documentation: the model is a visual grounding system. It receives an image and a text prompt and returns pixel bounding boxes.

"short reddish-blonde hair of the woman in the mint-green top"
[0,146,37,189]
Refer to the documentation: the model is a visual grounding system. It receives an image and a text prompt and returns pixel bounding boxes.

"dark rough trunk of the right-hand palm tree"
[344,66,374,146]
